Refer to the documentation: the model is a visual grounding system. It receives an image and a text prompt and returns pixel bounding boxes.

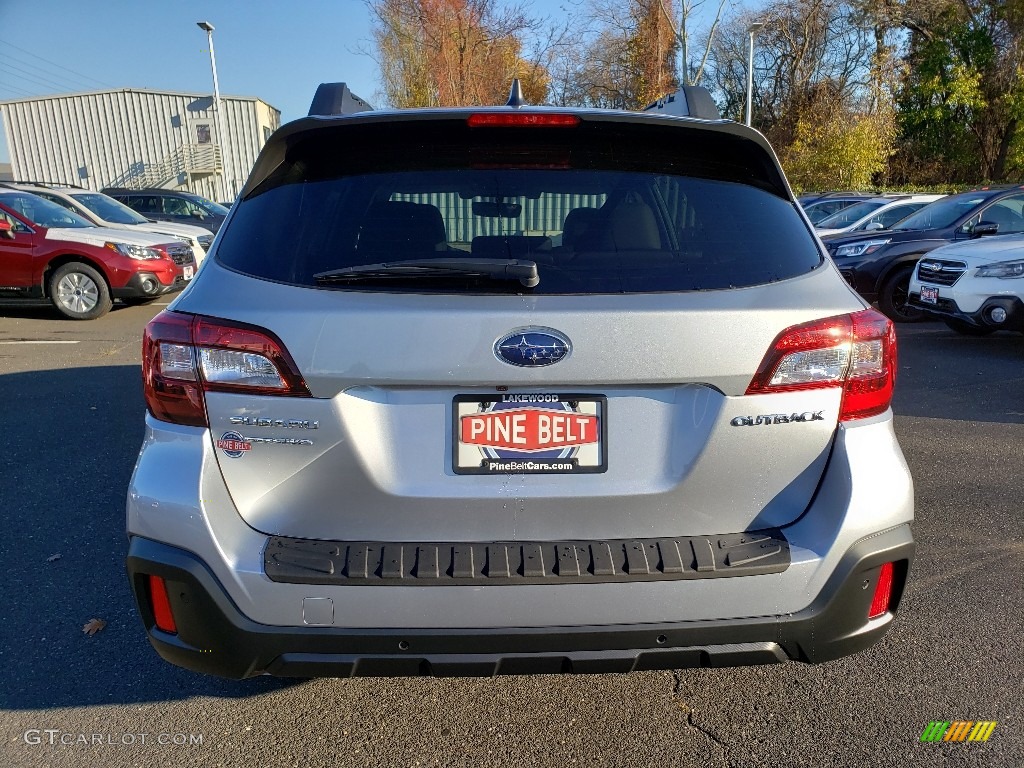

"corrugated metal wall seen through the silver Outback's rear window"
[392,193,607,243]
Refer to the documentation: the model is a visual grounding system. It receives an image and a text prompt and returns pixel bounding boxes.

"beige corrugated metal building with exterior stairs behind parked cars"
[0,89,281,201]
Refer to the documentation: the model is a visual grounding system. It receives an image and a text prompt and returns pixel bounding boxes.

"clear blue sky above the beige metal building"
[0,0,729,162]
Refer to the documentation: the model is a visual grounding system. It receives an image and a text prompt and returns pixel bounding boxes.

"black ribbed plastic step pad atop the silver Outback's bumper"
[263,528,790,587]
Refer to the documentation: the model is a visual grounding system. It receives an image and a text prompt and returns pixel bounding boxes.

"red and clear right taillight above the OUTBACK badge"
[746,309,896,421]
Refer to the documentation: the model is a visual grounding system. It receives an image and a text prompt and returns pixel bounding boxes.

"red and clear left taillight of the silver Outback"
[142,311,310,434]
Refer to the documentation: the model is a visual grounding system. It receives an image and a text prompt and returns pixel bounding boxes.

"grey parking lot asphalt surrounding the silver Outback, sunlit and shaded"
[0,305,1024,768]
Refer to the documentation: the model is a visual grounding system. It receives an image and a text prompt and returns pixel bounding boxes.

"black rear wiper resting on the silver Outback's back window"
[313,258,541,288]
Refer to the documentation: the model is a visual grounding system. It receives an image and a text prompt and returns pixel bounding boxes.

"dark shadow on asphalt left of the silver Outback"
[0,366,299,710]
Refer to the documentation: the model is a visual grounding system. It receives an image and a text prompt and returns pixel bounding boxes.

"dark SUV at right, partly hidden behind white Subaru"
[822,185,1024,323]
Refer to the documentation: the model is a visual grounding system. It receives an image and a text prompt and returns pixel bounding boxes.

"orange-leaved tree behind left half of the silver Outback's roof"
[367,0,549,108]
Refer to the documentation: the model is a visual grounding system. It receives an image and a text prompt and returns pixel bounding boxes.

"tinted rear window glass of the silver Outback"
[217,121,821,294]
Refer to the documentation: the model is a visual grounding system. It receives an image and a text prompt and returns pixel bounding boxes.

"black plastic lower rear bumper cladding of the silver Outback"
[127,524,914,678]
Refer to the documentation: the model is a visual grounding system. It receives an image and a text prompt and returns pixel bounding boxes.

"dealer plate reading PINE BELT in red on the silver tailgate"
[452,392,608,475]
